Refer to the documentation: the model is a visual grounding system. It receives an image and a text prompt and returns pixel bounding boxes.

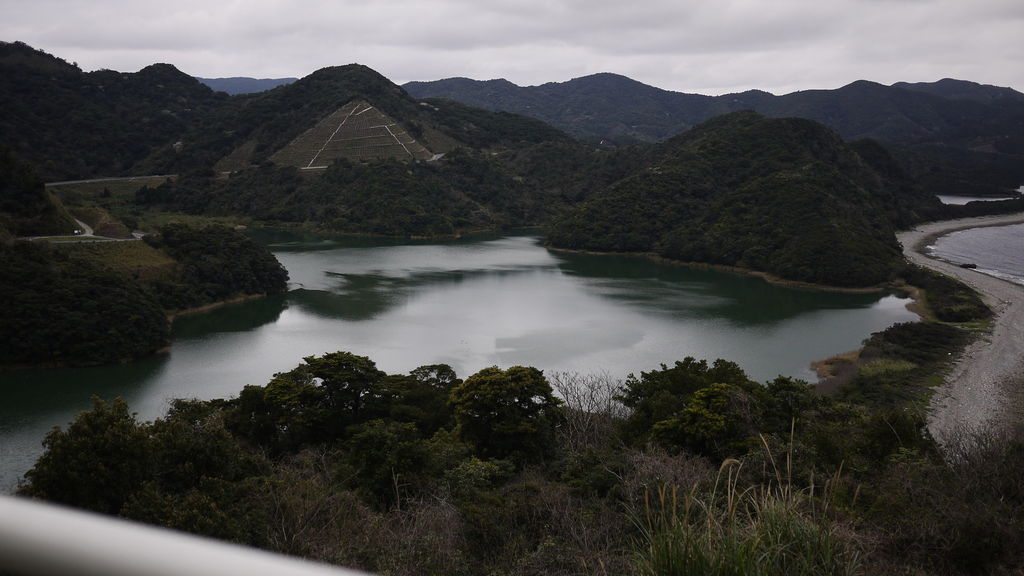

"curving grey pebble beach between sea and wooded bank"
[897,213,1024,450]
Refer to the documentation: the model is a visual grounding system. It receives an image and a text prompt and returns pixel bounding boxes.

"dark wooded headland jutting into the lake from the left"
[0,145,288,367]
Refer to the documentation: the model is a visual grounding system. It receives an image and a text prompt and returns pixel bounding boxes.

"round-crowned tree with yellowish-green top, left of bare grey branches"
[451,366,563,462]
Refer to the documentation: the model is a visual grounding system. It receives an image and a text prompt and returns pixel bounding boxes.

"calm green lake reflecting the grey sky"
[0,229,916,491]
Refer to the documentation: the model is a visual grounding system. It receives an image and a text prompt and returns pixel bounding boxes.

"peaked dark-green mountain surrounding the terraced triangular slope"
[143,65,567,172]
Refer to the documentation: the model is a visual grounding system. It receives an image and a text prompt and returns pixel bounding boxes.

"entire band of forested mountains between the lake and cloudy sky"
[0,43,1024,286]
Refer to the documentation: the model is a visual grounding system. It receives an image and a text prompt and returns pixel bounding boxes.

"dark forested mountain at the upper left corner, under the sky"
[0,42,227,181]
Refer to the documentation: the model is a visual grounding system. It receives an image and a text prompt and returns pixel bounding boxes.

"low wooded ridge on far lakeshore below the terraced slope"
[136,150,563,236]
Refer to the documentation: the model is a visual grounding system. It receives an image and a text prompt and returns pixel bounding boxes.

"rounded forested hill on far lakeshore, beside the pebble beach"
[548,112,938,286]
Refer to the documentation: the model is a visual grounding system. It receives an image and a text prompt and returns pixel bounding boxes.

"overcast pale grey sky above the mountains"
[0,0,1024,94]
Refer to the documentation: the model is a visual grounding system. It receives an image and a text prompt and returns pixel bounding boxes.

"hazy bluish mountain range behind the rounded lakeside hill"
[406,74,1024,195]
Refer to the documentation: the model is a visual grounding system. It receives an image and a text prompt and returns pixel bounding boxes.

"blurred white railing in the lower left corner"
[0,496,366,576]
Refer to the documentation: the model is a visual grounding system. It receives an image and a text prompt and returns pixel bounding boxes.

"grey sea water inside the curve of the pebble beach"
[929,224,1024,285]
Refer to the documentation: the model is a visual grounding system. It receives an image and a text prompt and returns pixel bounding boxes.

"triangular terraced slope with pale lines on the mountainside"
[270,99,433,169]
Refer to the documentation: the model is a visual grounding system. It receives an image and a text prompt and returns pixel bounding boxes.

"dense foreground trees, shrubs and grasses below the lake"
[19,282,1024,576]
